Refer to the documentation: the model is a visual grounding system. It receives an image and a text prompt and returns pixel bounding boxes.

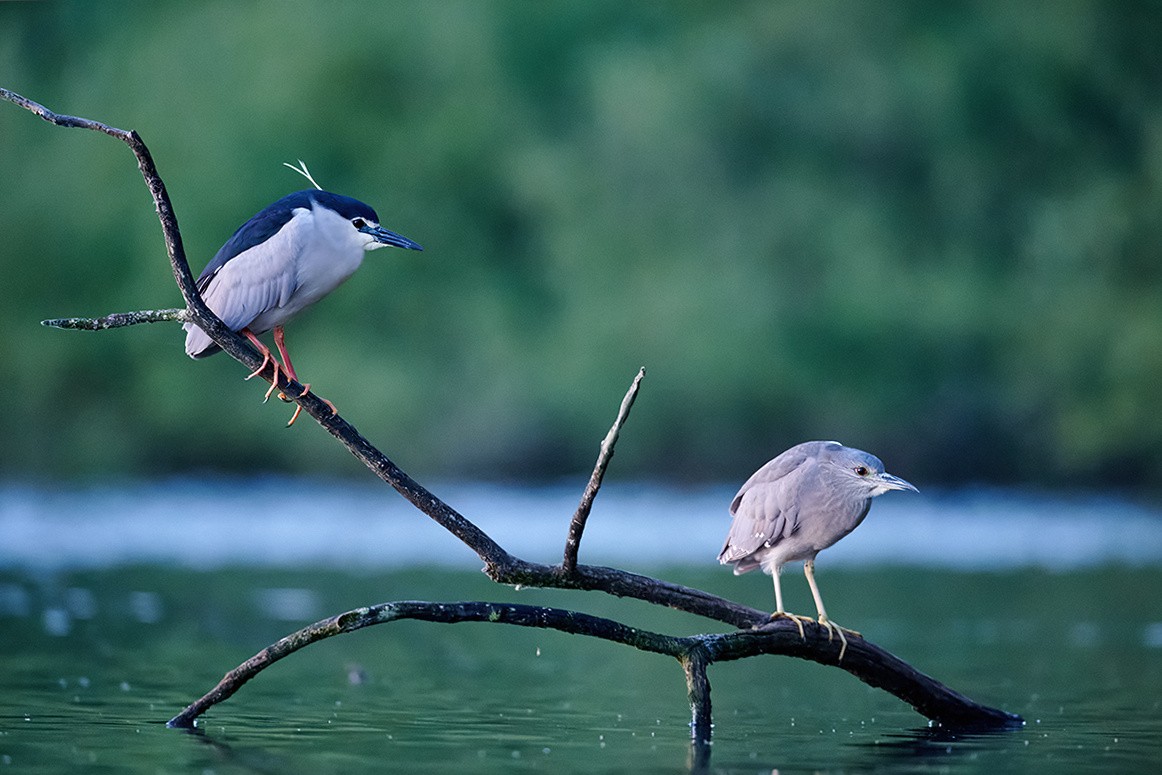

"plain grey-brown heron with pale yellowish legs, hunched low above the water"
[718,442,917,660]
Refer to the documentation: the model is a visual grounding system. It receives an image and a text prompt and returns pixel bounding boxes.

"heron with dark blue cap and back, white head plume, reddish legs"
[182,189,423,425]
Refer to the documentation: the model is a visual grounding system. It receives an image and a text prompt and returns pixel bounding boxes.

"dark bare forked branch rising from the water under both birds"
[9,88,1019,756]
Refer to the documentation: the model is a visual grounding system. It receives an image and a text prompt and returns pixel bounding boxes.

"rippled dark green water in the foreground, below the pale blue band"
[0,566,1162,773]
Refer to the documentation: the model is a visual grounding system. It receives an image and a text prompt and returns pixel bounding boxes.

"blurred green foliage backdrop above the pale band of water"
[0,0,1162,489]
